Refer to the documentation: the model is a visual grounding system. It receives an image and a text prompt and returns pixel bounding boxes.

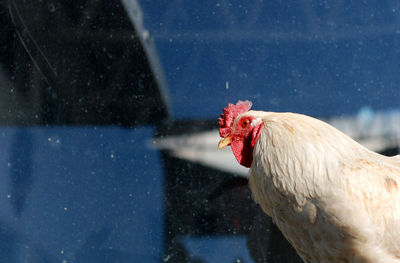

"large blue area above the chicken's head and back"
[140,0,400,118]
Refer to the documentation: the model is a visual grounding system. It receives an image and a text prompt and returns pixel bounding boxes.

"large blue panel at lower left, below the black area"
[0,127,163,262]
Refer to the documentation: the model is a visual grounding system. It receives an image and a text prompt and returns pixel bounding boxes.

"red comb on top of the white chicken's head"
[218,100,252,138]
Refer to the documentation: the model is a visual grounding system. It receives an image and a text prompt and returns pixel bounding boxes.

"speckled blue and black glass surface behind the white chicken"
[0,0,400,263]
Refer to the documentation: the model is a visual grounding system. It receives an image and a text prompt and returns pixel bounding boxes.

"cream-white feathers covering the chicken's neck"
[251,113,370,207]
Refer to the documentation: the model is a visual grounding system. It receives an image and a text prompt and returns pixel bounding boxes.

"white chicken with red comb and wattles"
[218,101,400,263]
